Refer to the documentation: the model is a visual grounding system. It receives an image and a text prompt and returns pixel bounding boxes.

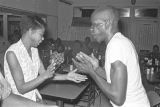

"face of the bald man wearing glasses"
[90,14,108,42]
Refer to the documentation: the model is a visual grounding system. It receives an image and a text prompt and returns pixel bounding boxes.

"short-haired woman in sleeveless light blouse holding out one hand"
[4,16,86,102]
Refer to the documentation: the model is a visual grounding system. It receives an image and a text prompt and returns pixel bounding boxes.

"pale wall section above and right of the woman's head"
[0,0,58,38]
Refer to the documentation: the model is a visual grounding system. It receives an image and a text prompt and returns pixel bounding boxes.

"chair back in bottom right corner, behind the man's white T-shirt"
[147,91,160,107]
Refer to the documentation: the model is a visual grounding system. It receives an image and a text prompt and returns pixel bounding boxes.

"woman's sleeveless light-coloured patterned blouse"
[4,39,40,101]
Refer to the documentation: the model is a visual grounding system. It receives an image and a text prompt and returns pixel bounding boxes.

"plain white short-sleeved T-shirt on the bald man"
[105,32,150,107]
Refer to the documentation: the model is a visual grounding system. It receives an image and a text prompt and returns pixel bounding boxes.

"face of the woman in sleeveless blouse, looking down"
[31,28,45,47]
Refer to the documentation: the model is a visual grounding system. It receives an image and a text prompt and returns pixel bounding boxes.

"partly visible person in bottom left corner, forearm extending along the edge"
[0,67,57,107]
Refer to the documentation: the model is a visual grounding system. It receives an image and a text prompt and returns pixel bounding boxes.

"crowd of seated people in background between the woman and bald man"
[38,37,105,70]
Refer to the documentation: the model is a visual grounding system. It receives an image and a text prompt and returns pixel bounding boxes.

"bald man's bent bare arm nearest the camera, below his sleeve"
[91,61,127,106]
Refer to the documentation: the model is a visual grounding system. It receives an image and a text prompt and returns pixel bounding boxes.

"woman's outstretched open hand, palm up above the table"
[66,69,87,83]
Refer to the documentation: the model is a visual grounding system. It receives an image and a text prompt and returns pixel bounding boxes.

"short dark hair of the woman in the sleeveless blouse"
[20,15,46,34]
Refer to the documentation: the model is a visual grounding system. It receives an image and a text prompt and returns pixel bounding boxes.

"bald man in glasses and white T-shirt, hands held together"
[73,6,150,107]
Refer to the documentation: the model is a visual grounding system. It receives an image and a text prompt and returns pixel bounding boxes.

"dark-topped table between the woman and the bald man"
[40,81,89,107]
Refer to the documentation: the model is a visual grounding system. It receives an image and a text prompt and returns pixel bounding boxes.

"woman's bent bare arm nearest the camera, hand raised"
[6,51,54,94]
